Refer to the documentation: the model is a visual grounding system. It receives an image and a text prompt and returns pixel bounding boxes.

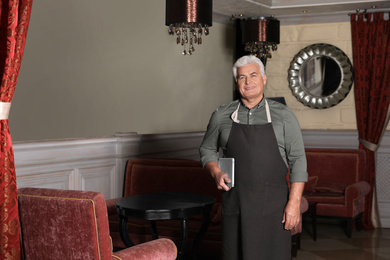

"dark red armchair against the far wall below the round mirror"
[303,148,370,237]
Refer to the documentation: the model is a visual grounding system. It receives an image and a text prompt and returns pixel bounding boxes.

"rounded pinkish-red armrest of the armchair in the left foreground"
[111,238,177,260]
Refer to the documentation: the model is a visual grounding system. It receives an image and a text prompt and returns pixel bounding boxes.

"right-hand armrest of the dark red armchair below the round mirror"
[345,181,371,217]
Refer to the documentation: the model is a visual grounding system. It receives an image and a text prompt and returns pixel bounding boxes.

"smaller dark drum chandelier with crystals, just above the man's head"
[241,17,280,59]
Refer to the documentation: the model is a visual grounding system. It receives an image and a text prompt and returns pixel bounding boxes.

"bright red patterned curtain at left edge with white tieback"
[0,0,32,259]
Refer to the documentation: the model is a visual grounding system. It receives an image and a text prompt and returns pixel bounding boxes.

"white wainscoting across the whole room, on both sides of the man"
[14,130,390,227]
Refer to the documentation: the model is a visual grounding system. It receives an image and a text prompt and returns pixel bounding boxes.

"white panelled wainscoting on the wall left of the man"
[14,132,204,199]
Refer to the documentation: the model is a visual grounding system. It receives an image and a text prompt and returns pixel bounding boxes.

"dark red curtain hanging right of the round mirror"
[351,13,390,229]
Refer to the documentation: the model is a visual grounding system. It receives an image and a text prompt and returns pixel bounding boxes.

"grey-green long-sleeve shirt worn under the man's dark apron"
[199,98,307,182]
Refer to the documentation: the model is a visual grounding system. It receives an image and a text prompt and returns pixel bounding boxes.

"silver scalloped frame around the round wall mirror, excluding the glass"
[288,43,353,109]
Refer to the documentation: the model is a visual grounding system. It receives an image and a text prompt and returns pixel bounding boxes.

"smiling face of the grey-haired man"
[237,64,267,105]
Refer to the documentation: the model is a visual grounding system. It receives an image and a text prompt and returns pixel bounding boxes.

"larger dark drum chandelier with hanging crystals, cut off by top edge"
[165,0,213,55]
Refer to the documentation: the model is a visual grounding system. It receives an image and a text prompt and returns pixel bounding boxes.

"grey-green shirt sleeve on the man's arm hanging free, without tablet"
[283,107,308,182]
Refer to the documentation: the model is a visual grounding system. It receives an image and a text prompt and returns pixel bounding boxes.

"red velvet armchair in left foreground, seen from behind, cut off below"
[18,188,177,260]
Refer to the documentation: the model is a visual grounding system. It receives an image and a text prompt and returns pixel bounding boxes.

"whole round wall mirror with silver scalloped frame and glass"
[288,43,353,109]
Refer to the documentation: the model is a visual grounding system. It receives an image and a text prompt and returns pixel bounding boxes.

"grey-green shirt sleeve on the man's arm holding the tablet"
[199,110,219,167]
